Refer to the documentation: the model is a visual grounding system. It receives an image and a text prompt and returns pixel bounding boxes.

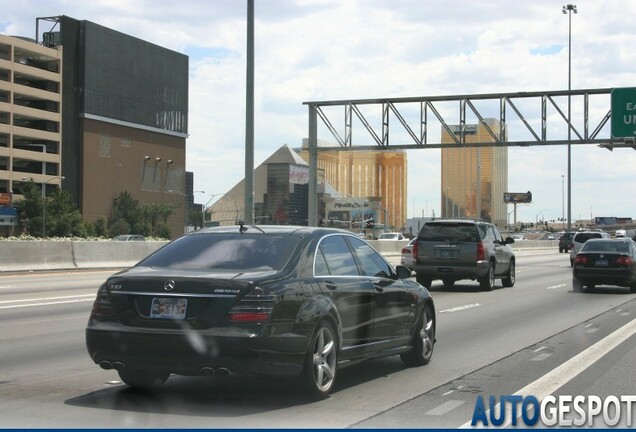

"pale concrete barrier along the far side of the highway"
[0,240,559,273]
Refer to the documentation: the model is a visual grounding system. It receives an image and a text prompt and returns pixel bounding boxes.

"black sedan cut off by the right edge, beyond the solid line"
[572,238,636,293]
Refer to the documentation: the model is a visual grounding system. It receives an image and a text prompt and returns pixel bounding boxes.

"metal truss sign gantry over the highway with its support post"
[304,88,636,225]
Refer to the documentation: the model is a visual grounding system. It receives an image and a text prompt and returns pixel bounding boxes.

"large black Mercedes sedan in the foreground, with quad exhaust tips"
[86,225,436,398]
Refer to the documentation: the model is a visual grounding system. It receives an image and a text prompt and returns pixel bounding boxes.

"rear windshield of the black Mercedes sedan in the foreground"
[138,233,299,272]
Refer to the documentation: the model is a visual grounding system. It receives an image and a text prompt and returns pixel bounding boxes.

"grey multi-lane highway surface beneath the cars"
[0,249,636,428]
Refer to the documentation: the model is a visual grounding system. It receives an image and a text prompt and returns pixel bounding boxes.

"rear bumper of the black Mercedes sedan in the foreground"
[86,328,309,377]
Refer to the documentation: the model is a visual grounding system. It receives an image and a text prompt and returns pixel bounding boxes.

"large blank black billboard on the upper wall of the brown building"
[80,21,188,134]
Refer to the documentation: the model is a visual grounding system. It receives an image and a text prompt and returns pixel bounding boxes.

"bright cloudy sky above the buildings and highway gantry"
[0,0,636,226]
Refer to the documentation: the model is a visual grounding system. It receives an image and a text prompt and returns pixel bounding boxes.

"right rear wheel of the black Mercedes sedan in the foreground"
[301,320,338,399]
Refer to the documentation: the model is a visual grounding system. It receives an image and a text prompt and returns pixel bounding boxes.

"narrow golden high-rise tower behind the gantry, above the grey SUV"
[441,119,508,226]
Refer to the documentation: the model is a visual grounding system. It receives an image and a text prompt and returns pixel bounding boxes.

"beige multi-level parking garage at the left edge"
[0,35,63,234]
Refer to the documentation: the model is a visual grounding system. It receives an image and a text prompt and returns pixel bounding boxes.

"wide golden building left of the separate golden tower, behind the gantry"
[300,143,407,230]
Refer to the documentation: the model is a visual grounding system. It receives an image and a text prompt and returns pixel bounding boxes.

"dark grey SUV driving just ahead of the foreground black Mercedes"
[413,219,515,291]
